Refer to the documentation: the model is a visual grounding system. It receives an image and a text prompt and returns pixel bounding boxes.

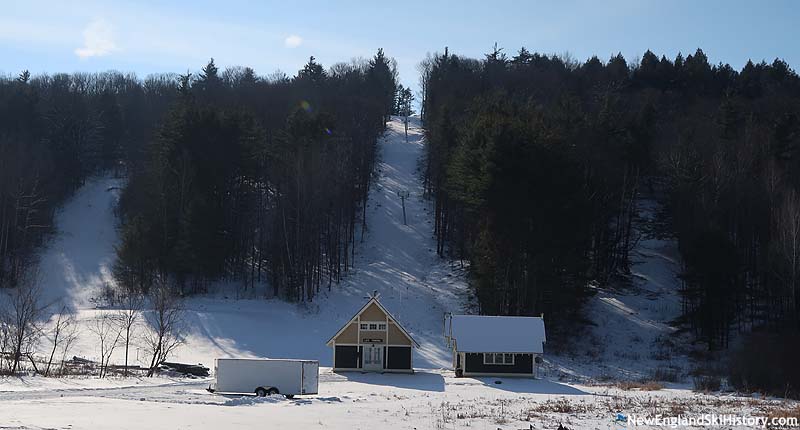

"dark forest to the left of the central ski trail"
[0,51,397,301]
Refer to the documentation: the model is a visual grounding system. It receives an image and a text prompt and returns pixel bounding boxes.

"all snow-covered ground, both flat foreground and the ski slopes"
[0,119,787,429]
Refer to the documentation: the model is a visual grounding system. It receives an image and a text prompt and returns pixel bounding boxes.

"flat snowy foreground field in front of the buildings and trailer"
[0,369,796,430]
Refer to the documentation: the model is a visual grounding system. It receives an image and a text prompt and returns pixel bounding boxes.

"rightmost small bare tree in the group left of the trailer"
[144,276,185,376]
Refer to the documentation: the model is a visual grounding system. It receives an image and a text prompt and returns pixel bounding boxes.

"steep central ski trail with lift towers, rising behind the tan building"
[328,118,469,367]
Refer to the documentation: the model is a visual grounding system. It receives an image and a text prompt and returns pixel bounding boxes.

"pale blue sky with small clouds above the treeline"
[0,0,800,90]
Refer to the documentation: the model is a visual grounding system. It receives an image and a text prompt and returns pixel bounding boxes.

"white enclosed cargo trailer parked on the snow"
[208,358,319,398]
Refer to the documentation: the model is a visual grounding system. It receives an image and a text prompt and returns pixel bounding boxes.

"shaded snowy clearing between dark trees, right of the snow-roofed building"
[547,199,691,385]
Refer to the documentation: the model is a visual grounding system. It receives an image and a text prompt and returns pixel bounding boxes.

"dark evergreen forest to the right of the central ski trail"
[420,47,800,386]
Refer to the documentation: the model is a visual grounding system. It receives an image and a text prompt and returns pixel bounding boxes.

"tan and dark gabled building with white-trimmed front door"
[327,296,419,373]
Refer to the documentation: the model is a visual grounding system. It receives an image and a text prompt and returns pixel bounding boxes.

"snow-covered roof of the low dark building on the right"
[451,315,546,354]
